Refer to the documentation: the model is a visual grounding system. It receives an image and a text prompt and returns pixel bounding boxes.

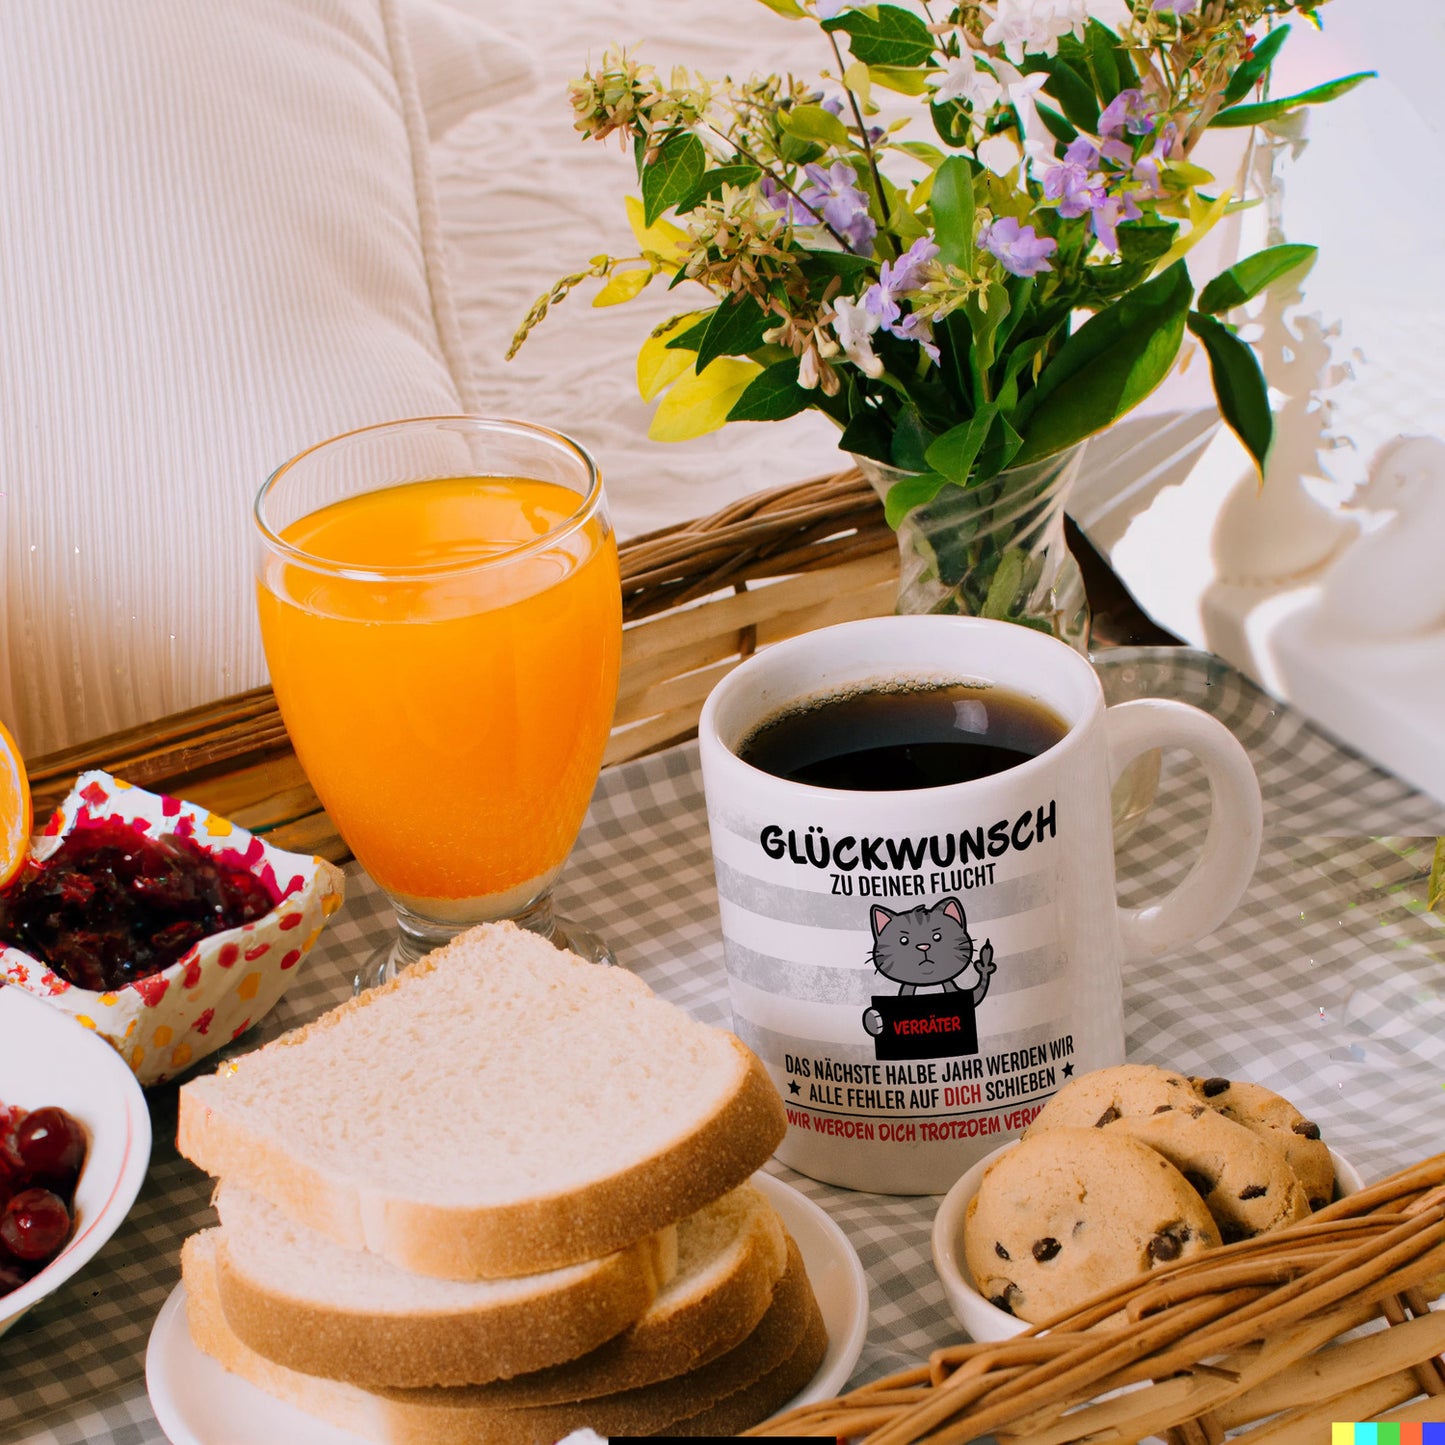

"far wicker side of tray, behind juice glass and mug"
[27,471,897,863]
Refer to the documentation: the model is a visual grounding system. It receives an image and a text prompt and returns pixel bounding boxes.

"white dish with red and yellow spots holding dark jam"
[0,772,342,1084]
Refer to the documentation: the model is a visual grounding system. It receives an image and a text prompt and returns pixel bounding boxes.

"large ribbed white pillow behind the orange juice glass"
[0,0,491,756]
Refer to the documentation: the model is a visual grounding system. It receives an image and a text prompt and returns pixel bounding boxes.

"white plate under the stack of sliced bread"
[146,1173,868,1445]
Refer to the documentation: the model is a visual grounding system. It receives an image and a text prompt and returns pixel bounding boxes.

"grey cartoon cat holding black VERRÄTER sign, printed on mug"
[863,897,998,1061]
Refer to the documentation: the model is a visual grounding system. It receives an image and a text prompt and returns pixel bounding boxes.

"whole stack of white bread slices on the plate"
[178,923,827,1445]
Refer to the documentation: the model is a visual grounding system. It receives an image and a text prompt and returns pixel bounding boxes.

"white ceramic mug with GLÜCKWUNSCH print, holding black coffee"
[699,616,1261,1194]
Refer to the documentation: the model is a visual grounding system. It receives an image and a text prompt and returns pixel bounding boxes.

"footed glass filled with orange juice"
[254,416,621,988]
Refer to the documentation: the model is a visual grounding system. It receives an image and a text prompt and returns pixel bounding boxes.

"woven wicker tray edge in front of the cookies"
[747,1155,1445,1445]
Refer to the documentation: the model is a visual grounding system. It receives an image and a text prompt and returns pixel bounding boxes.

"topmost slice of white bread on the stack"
[176,923,786,1279]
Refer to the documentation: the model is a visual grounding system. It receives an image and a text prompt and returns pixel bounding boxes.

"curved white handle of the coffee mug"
[1104,698,1264,962]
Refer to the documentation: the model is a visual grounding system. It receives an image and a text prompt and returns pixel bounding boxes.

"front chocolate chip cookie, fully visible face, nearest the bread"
[964,1116,1225,1324]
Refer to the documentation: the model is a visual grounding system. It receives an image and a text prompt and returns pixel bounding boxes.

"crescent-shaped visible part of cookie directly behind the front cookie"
[1104,1108,1309,1244]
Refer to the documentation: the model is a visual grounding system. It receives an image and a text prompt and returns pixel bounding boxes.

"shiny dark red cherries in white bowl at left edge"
[0,1104,85,1296]
